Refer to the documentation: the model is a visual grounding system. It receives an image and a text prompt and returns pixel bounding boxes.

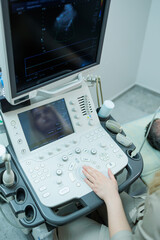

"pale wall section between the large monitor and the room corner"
[91,0,151,106]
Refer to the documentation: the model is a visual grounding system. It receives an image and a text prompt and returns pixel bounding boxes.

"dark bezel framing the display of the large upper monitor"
[1,0,111,98]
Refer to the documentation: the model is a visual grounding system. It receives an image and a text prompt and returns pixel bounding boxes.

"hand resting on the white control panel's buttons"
[82,166,118,203]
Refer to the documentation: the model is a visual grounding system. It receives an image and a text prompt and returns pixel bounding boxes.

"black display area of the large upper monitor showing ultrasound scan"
[9,0,105,92]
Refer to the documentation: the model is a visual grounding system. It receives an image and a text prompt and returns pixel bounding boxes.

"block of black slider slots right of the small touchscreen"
[78,95,93,116]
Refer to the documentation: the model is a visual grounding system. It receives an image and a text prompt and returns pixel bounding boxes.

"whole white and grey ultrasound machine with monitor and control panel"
[0,0,143,239]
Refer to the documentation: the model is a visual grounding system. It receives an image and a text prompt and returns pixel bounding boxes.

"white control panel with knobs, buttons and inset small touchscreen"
[1,83,128,207]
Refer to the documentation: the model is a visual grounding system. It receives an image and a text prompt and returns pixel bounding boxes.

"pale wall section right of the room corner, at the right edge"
[136,0,160,93]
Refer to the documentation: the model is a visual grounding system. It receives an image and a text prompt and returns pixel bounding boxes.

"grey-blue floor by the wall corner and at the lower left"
[0,86,160,240]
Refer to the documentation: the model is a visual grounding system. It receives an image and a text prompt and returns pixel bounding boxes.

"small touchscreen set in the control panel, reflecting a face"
[18,99,74,151]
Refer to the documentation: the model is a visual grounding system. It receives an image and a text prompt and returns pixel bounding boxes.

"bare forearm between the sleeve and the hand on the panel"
[105,192,131,237]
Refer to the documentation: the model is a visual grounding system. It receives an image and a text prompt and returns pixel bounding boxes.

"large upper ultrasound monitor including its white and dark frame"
[0,0,110,104]
